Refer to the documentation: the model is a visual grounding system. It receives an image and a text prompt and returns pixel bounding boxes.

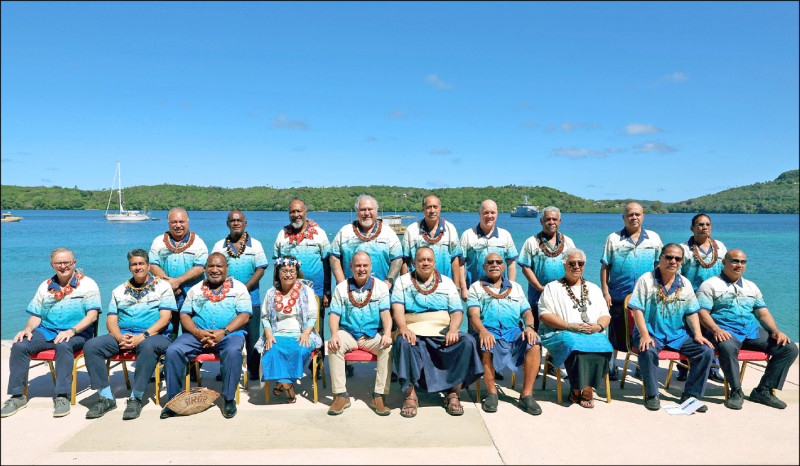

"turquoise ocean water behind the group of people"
[0,210,800,341]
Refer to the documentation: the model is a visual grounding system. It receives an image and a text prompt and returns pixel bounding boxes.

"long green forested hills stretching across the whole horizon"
[0,170,798,213]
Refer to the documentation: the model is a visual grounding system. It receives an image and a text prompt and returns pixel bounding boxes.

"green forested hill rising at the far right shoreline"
[669,170,800,214]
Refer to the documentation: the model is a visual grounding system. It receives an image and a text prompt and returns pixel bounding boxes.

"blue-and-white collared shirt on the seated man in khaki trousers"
[328,277,389,339]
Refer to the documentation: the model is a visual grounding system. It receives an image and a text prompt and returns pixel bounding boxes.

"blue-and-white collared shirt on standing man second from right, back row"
[600,228,663,301]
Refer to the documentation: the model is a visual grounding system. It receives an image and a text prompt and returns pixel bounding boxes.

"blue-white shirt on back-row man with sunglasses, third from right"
[461,223,519,285]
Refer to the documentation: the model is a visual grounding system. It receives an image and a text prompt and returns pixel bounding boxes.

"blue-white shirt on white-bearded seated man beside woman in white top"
[467,277,531,341]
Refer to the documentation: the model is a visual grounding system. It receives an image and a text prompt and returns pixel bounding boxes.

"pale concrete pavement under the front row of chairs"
[0,341,800,465]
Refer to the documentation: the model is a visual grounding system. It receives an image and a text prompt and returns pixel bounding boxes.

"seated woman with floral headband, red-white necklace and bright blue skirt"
[256,256,322,403]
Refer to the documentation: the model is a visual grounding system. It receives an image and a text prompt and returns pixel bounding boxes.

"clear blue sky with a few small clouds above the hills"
[0,2,800,203]
